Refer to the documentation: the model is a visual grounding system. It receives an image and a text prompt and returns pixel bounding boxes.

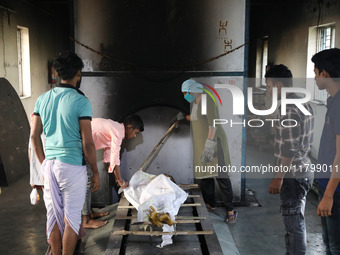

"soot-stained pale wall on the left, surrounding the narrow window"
[0,0,68,119]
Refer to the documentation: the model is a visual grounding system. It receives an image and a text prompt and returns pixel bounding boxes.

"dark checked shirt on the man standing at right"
[274,93,314,169]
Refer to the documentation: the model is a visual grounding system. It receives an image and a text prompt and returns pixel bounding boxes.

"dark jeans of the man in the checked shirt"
[280,178,313,255]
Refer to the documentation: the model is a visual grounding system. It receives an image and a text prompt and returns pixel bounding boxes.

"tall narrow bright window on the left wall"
[17,26,31,98]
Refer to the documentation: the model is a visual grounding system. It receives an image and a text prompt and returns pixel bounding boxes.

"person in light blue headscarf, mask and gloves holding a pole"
[182,79,237,223]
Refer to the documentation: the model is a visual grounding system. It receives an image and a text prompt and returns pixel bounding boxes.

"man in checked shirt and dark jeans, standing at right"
[265,65,314,255]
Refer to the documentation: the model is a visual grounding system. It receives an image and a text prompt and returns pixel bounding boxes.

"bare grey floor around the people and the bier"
[0,147,324,255]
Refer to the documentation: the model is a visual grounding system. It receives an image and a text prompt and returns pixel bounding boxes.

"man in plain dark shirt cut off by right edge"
[312,49,340,254]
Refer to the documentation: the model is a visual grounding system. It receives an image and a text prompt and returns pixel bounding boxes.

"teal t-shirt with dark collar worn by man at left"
[34,81,92,166]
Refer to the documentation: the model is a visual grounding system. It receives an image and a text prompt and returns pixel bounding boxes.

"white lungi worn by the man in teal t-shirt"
[41,159,87,238]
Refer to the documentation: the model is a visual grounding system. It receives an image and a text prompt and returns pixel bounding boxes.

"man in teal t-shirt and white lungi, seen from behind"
[31,52,100,254]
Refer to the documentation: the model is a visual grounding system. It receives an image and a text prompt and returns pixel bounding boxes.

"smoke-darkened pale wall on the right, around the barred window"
[249,0,340,158]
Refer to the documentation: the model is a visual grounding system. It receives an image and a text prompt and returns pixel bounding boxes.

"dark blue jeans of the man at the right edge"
[319,187,340,255]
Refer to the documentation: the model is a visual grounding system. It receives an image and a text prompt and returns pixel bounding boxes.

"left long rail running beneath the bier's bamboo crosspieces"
[105,195,130,255]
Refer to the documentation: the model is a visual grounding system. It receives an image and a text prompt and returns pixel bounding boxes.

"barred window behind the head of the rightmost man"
[306,23,335,104]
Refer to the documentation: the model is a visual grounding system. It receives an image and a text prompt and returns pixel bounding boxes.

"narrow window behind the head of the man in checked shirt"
[255,36,268,87]
